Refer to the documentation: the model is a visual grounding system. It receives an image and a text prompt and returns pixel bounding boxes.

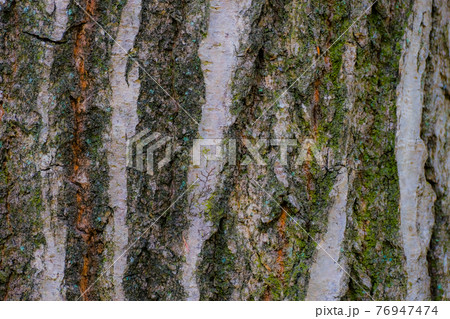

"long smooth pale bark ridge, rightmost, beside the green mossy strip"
[395,0,436,300]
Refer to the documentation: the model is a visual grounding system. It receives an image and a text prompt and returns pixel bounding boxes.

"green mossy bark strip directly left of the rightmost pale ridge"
[342,1,412,300]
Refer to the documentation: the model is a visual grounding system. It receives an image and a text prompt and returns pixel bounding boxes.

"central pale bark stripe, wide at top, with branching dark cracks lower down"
[182,0,250,300]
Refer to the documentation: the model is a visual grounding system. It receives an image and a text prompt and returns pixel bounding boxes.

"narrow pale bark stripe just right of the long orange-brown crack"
[108,0,141,300]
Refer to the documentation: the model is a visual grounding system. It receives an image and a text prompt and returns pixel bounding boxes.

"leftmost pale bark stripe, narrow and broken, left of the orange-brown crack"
[33,0,70,300]
